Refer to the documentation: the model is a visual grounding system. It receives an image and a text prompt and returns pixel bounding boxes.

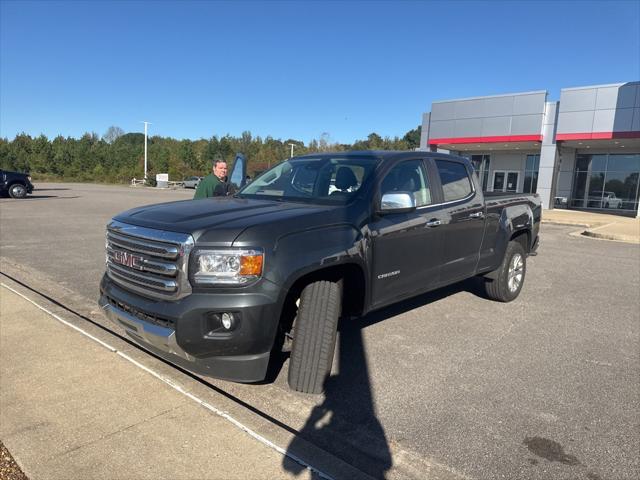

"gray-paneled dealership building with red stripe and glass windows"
[420,82,640,216]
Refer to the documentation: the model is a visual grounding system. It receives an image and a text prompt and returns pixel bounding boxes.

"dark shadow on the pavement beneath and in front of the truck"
[283,279,485,478]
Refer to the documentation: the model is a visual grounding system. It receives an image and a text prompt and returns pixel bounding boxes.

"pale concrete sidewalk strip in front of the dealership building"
[542,209,640,244]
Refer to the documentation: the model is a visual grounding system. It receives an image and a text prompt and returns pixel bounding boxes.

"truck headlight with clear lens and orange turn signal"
[192,249,264,285]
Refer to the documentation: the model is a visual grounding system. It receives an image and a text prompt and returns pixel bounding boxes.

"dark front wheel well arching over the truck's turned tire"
[280,264,366,340]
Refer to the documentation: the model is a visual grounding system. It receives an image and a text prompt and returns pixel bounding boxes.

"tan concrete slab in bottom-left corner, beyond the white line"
[0,286,315,480]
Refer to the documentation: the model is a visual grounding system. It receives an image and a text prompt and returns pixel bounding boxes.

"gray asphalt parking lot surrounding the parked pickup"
[0,184,640,480]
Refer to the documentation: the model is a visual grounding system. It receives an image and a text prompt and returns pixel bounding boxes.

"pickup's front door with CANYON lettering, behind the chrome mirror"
[369,158,442,306]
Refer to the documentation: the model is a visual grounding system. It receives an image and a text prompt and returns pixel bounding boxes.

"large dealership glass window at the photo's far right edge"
[570,154,640,212]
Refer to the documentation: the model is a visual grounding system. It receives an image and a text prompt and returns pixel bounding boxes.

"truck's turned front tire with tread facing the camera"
[289,280,342,393]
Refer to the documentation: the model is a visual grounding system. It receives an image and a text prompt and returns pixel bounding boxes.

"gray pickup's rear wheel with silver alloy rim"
[484,241,527,302]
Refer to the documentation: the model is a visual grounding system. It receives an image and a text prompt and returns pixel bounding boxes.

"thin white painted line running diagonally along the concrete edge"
[0,282,333,480]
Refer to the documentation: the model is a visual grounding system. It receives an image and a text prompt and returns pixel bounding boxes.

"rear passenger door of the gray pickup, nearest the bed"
[432,158,486,284]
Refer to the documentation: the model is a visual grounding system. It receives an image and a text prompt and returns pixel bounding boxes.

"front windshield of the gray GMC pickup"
[238,157,376,204]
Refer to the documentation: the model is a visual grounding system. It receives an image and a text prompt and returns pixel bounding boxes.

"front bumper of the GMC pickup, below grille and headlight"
[99,275,280,382]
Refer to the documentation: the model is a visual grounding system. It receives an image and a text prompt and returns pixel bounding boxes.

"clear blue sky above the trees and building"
[0,0,640,143]
